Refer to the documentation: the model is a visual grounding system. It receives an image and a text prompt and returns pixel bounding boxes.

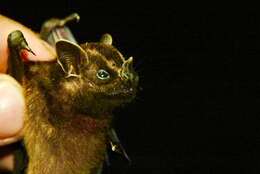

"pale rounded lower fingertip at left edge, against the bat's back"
[0,74,25,139]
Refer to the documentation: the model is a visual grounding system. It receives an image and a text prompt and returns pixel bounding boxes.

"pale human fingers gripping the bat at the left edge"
[0,14,55,170]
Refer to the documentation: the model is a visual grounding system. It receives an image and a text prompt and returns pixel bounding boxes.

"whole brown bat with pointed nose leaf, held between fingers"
[8,14,138,174]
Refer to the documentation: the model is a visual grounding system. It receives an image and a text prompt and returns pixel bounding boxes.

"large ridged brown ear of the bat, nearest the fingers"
[56,40,87,77]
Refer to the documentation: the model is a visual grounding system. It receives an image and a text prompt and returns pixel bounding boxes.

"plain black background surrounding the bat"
[0,3,260,174]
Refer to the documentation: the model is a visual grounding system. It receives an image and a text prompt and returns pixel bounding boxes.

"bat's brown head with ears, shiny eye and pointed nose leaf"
[46,34,139,116]
